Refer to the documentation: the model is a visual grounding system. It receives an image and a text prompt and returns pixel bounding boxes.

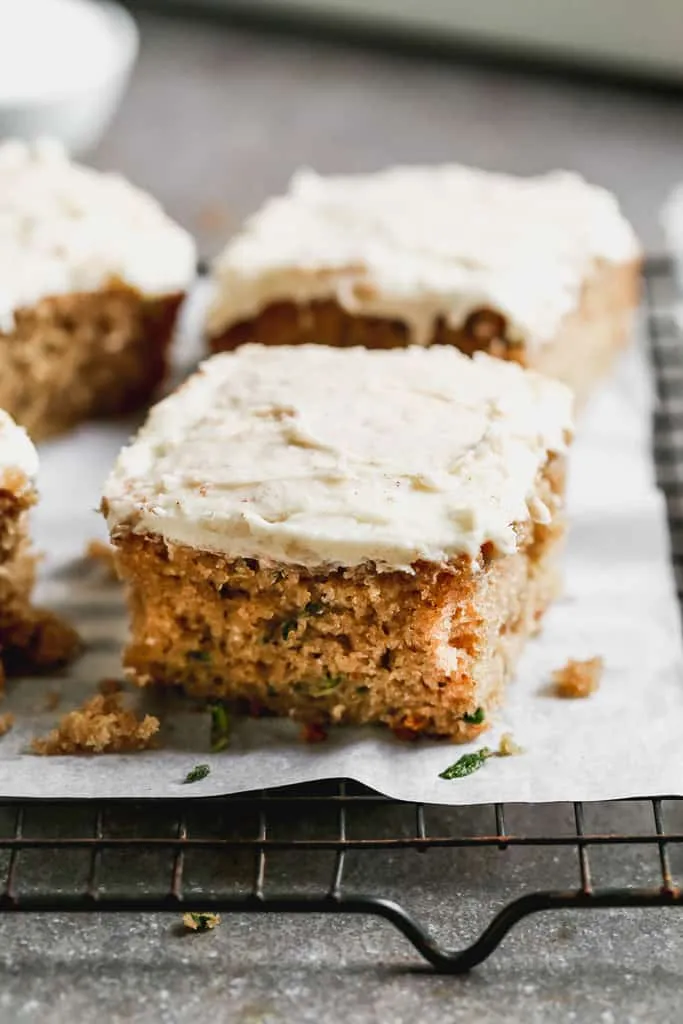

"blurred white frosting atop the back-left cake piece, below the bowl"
[0,140,196,331]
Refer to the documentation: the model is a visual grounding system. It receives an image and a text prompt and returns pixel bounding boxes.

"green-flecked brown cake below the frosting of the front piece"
[116,458,564,740]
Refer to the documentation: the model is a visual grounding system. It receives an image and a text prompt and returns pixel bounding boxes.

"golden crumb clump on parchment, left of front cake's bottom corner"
[31,693,159,757]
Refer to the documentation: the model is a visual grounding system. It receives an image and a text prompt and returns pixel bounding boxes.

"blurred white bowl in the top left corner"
[0,0,138,155]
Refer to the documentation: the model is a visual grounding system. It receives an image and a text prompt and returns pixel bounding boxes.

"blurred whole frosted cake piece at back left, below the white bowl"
[0,140,196,439]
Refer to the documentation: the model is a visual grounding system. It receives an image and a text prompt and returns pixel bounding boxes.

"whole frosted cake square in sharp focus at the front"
[102,345,572,739]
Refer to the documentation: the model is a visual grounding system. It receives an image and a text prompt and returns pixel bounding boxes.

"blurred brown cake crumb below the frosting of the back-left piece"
[0,283,182,440]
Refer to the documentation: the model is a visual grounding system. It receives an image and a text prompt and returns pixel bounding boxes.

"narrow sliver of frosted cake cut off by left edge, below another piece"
[0,410,38,682]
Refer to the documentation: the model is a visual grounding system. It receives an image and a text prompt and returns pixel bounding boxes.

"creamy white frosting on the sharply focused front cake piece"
[104,345,572,570]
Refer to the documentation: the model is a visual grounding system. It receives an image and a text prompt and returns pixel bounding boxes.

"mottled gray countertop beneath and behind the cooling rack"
[0,9,683,1024]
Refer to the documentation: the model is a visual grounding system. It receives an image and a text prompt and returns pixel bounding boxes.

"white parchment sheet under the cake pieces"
[0,315,683,804]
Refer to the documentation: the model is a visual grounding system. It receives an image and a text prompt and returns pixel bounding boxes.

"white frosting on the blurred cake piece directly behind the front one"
[208,165,639,345]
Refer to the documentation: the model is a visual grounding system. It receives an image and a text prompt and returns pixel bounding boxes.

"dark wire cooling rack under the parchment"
[0,253,683,973]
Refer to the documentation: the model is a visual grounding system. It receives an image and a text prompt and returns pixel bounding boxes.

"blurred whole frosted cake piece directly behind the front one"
[207,165,640,403]
